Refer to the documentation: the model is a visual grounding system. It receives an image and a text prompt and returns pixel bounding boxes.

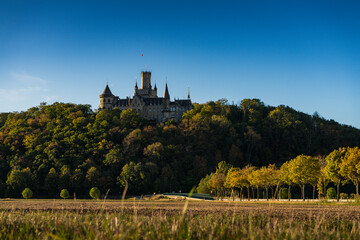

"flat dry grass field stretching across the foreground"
[0,200,360,239]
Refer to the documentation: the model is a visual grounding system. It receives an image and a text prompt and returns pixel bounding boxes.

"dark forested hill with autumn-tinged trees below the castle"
[0,99,360,197]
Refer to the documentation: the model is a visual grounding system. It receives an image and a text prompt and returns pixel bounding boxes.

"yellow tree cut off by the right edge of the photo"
[340,147,360,197]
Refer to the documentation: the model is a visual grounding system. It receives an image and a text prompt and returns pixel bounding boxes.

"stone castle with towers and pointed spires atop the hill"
[100,71,193,122]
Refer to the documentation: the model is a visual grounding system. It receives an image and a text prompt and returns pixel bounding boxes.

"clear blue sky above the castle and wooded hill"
[0,0,360,128]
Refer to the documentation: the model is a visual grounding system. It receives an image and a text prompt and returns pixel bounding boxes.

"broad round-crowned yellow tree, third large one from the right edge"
[290,155,320,201]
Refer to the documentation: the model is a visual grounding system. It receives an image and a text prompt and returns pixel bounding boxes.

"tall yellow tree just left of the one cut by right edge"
[324,148,347,201]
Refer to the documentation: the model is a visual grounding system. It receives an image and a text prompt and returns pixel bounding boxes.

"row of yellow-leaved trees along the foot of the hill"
[197,147,360,201]
